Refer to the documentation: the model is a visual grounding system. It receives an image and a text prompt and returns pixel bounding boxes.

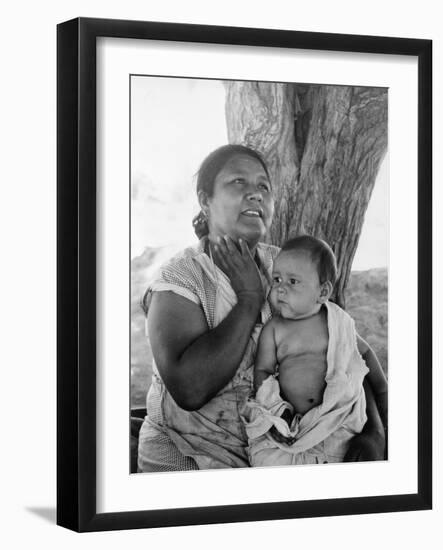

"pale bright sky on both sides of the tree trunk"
[131,76,388,270]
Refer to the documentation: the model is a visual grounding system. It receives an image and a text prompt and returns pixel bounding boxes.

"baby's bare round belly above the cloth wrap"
[279,354,326,414]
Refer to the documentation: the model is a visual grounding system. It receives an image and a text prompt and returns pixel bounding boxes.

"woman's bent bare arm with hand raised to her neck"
[148,235,264,410]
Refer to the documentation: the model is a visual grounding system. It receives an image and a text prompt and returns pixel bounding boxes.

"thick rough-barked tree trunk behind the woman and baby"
[226,82,387,306]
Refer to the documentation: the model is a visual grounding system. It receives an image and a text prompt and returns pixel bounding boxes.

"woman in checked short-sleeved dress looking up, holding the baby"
[138,145,384,472]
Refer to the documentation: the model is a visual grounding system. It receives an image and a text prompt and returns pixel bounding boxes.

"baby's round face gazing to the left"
[270,251,321,319]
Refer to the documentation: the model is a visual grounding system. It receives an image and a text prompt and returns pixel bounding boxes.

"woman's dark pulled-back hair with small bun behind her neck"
[192,145,269,239]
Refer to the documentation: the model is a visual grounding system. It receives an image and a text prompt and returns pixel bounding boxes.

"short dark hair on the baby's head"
[281,235,337,286]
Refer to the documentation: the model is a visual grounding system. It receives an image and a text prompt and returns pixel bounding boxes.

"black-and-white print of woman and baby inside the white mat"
[128,74,390,474]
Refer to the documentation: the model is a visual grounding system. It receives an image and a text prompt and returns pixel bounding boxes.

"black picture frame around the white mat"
[57,18,432,531]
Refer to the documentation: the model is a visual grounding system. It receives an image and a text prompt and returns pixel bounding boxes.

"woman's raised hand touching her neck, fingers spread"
[213,236,265,306]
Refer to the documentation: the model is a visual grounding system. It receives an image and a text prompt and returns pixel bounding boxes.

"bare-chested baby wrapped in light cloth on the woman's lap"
[246,236,387,466]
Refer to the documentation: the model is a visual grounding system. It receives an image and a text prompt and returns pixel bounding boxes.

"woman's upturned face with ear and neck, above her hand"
[203,155,274,247]
